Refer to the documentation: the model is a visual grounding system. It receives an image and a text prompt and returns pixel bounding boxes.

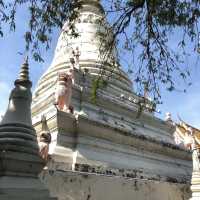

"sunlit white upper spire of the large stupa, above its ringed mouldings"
[49,0,111,67]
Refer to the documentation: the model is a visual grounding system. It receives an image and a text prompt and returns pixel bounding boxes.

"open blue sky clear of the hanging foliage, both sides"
[0,3,200,128]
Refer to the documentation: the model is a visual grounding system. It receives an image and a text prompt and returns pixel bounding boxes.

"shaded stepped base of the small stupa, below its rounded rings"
[0,152,55,200]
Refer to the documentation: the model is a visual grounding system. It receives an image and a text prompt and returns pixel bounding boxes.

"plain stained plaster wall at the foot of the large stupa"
[41,170,190,200]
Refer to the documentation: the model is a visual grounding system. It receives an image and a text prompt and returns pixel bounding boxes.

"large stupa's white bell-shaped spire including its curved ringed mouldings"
[35,0,132,107]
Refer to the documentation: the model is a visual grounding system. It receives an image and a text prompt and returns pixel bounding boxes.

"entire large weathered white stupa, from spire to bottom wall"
[32,0,191,200]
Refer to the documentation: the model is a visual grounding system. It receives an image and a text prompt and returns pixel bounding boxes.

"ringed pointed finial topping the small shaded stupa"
[15,56,32,87]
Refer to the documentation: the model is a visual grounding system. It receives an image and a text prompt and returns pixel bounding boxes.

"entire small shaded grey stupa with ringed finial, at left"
[0,60,55,200]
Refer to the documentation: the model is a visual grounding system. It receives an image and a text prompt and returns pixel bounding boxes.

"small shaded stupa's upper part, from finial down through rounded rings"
[0,59,39,155]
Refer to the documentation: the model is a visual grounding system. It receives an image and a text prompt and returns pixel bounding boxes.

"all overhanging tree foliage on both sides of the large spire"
[0,0,200,102]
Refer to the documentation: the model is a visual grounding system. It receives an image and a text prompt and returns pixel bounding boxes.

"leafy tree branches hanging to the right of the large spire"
[107,0,200,103]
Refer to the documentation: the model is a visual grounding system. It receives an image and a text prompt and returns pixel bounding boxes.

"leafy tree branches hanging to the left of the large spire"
[0,0,80,61]
